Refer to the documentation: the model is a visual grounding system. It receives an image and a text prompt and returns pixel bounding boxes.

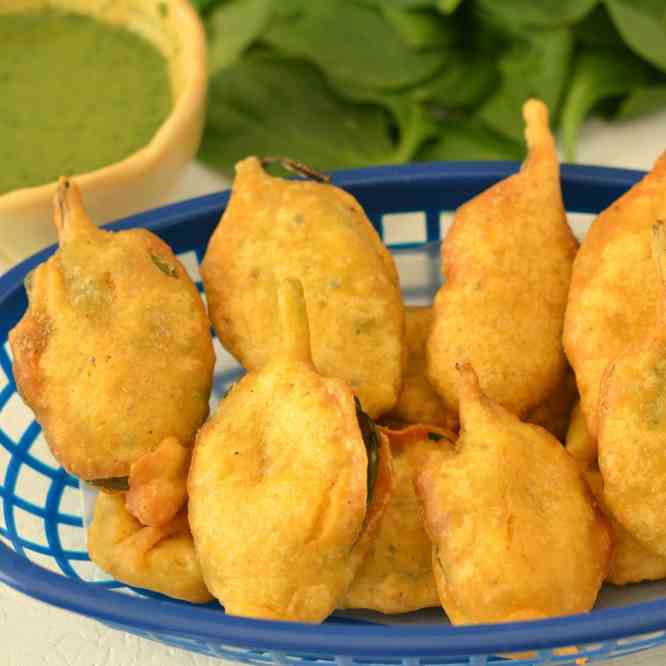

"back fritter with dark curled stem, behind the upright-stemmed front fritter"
[201,157,404,418]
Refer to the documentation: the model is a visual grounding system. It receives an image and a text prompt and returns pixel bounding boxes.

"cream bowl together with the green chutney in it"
[0,0,207,265]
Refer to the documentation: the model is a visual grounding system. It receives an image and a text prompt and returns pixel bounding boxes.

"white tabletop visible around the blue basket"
[0,112,666,666]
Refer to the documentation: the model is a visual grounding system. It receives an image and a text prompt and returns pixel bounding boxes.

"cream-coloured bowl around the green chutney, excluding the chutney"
[0,0,207,264]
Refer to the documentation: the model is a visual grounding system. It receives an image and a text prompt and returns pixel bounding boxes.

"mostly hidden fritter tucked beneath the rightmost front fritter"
[567,405,666,585]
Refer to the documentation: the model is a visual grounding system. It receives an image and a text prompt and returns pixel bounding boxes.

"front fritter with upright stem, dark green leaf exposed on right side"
[188,280,392,622]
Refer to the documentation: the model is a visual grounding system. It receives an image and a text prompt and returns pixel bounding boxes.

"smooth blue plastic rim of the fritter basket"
[0,162,666,658]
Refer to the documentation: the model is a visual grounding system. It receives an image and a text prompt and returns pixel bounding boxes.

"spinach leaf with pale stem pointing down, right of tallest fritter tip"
[560,50,650,160]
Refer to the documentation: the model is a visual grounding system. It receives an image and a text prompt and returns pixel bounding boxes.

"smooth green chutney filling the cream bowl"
[0,10,172,194]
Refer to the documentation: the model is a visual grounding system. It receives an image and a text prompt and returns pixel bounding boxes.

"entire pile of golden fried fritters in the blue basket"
[10,106,666,624]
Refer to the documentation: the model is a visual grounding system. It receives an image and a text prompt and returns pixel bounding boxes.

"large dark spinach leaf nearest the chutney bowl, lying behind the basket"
[199,52,396,172]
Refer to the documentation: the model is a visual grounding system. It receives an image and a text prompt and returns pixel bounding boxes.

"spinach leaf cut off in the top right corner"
[604,0,666,72]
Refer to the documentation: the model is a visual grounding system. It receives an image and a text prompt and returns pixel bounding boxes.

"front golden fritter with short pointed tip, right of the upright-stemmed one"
[416,364,611,624]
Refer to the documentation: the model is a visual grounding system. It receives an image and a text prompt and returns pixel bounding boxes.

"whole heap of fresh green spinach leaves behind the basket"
[193,0,666,172]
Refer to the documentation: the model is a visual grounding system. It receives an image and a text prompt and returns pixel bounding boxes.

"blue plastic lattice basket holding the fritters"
[0,162,666,666]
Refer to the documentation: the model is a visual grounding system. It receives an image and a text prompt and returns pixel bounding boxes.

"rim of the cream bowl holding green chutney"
[0,0,208,208]
